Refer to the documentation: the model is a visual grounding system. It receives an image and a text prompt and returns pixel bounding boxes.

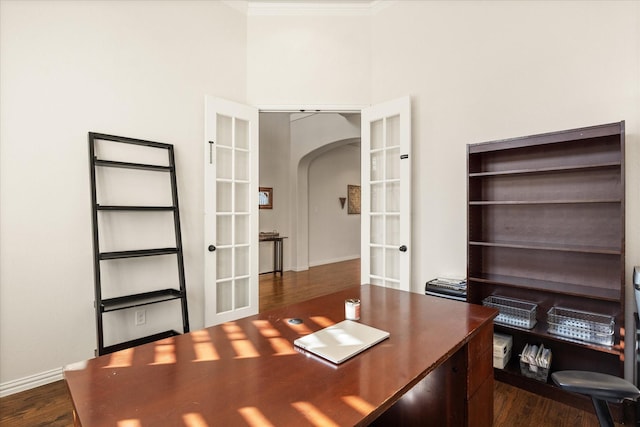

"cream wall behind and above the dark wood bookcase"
[371,1,640,372]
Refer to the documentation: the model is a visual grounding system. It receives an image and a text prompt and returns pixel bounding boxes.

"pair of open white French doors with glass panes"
[204,96,411,327]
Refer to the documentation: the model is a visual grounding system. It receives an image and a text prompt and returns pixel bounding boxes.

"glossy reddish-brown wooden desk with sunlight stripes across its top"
[64,285,497,427]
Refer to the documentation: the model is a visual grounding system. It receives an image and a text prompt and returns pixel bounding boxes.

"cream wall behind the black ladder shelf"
[0,0,247,391]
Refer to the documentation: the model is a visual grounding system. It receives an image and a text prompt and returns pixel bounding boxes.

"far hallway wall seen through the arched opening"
[309,144,360,266]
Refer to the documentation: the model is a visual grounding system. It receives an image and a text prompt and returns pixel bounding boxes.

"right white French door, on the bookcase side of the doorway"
[360,96,411,291]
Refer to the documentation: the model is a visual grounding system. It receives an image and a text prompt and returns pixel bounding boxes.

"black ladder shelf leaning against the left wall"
[89,132,189,356]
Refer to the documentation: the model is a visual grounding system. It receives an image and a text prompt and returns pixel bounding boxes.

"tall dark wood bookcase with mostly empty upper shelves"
[467,122,625,408]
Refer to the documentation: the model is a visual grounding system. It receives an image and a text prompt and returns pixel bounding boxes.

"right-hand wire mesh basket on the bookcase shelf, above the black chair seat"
[547,307,615,346]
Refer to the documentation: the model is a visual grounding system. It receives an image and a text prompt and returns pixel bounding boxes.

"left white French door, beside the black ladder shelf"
[204,96,259,327]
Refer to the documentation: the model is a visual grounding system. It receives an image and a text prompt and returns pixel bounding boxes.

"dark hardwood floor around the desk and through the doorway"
[0,260,598,427]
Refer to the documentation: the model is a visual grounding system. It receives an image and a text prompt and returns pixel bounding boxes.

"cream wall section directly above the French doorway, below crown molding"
[247,11,371,106]
